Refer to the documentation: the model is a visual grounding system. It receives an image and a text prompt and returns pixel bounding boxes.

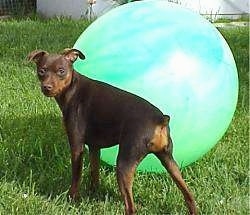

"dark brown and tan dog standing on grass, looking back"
[28,49,197,215]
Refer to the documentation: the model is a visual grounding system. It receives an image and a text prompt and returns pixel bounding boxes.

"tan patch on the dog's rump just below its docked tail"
[148,125,168,152]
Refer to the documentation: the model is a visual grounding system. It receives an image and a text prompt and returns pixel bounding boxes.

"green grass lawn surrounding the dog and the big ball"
[0,19,249,215]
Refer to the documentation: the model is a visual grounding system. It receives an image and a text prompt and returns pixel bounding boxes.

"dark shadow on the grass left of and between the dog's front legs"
[0,114,120,201]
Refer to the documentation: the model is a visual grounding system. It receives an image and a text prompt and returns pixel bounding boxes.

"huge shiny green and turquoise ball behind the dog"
[74,0,238,172]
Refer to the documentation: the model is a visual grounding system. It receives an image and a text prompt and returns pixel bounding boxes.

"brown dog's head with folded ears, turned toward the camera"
[28,49,85,97]
